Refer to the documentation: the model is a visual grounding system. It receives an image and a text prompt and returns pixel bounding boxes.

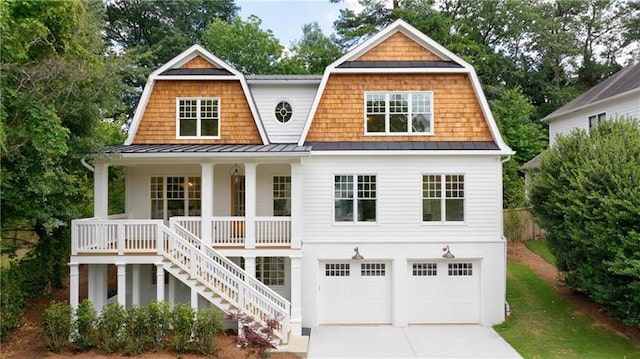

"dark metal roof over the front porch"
[102,144,311,154]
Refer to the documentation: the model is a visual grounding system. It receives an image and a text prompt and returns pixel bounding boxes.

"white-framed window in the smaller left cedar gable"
[176,98,220,138]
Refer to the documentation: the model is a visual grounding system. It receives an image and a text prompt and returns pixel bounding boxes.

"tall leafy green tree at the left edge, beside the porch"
[0,0,120,292]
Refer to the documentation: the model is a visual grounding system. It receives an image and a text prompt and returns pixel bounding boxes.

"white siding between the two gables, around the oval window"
[250,83,318,143]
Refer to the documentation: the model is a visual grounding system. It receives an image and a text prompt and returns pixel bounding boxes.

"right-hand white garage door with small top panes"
[407,261,480,324]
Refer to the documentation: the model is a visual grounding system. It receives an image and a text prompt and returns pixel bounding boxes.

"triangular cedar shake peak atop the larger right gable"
[355,32,442,61]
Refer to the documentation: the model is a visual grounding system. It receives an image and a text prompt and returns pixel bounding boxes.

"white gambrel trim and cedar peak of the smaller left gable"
[124,45,269,145]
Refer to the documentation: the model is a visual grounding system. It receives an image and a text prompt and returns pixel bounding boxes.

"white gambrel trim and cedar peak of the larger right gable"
[298,20,513,155]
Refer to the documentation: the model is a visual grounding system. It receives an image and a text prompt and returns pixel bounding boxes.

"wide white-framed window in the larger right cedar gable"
[365,91,433,135]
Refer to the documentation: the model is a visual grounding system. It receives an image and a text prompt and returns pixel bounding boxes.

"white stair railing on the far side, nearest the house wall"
[171,221,291,313]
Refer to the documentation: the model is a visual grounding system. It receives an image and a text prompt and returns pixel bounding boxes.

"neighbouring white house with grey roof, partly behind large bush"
[521,63,640,179]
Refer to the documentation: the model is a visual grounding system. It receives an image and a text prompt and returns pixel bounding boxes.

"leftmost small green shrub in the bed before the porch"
[42,301,72,353]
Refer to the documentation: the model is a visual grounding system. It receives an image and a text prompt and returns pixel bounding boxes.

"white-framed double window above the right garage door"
[422,174,464,222]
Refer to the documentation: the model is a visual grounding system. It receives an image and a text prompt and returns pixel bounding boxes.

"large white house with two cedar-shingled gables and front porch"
[70,20,513,343]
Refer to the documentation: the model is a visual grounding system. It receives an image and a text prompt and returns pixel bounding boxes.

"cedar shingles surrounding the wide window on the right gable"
[306,74,493,142]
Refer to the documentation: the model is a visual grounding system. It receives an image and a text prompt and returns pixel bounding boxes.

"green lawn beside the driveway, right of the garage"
[495,263,640,359]
